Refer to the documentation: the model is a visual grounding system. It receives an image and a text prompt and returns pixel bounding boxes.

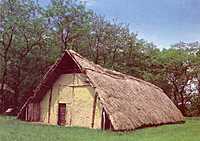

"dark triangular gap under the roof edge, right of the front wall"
[101,108,113,130]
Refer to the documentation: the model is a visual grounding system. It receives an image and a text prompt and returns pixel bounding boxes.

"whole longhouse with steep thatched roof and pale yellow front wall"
[18,50,184,131]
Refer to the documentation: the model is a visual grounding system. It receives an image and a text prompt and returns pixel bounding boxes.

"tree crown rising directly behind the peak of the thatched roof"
[44,0,91,54]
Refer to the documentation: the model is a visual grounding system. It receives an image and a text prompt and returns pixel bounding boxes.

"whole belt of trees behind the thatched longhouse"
[0,0,200,116]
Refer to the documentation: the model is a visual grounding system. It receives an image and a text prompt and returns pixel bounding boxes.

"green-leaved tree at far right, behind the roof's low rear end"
[144,43,199,115]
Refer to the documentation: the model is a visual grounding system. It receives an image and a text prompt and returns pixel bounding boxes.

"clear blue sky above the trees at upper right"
[40,0,200,48]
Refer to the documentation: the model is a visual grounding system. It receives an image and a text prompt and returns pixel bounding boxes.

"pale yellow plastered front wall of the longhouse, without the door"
[40,74,101,128]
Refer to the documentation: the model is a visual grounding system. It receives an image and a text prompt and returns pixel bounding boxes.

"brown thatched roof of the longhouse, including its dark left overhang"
[17,51,184,130]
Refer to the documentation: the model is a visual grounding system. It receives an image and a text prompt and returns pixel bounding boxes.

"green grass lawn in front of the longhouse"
[0,116,200,141]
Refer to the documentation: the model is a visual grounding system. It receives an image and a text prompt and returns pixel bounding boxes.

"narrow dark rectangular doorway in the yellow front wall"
[58,103,66,126]
